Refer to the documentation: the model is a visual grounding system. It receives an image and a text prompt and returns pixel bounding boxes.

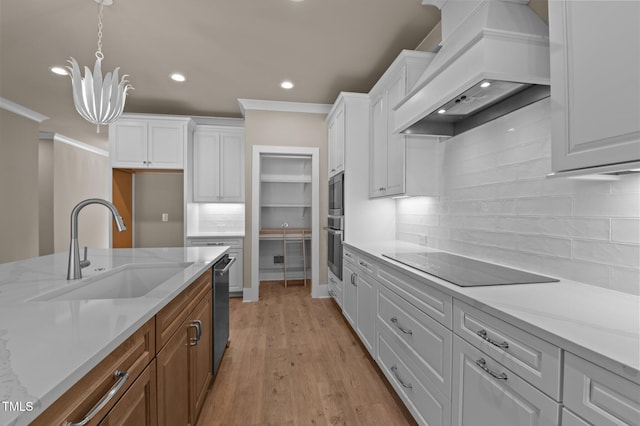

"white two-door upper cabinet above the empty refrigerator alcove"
[109,114,191,169]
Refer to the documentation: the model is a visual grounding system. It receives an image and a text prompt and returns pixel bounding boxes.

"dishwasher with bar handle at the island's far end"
[212,254,236,377]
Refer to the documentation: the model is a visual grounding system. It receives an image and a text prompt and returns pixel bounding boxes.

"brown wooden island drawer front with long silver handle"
[31,319,156,426]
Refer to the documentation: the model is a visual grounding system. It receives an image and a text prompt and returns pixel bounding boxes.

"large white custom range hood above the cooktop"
[394,0,549,136]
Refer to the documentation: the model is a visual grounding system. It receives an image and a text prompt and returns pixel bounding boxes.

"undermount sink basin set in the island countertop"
[31,263,192,301]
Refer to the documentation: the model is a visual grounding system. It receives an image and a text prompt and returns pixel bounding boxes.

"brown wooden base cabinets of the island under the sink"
[31,269,213,426]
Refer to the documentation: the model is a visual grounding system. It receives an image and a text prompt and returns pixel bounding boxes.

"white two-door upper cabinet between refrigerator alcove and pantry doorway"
[193,126,244,203]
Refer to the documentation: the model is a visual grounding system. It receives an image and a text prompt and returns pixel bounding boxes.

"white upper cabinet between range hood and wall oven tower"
[369,50,438,198]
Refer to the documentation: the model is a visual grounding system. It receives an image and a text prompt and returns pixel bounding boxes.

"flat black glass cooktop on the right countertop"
[382,252,558,287]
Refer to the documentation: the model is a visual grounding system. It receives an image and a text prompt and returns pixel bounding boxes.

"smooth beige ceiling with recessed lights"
[0,0,440,148]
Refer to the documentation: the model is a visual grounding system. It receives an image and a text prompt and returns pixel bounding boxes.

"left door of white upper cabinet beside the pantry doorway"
[193,131,220,202]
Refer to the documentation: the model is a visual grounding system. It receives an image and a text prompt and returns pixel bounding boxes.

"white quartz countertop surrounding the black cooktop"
[345,242,640,383]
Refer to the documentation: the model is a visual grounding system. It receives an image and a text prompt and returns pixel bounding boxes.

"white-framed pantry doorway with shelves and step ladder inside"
[250,145,320,301]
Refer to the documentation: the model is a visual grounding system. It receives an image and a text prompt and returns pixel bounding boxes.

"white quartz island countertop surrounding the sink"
[0,246,229,425]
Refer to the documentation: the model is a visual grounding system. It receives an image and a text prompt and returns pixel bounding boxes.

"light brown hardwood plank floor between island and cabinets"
[198,283,415,426]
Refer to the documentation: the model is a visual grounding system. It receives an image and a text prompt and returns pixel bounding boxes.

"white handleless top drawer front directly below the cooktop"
[378,265,453,329]
